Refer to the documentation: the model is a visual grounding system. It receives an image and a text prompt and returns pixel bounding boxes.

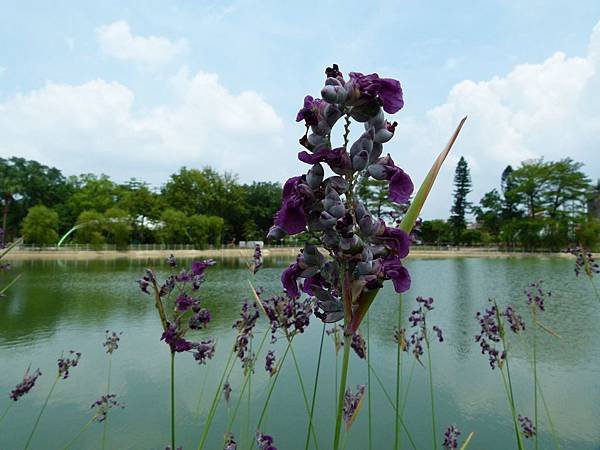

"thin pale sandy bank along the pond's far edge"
[3,246,584,260]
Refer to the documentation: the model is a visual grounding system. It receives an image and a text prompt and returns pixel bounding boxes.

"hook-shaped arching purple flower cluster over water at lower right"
[475,300,525,369]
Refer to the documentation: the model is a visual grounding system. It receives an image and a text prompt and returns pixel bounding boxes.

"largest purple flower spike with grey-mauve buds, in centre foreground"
[268,64,414,335]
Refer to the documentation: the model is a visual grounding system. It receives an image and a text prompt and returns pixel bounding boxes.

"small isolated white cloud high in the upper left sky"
[96,20,187,65]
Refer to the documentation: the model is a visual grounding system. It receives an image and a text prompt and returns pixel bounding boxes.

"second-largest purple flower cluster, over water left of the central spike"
[137,255,215,364]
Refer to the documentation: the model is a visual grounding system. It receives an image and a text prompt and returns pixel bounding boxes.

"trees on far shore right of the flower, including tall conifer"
[418,158,600,251]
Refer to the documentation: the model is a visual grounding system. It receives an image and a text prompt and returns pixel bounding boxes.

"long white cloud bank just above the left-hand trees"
[0,70,283,183]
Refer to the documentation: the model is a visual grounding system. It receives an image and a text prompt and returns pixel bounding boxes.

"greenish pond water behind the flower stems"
[0,258,600,450]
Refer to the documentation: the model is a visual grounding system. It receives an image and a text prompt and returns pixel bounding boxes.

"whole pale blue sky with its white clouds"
[0,0,600,219]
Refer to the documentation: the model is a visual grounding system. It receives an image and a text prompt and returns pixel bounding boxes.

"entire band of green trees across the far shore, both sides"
[0,157,600,250]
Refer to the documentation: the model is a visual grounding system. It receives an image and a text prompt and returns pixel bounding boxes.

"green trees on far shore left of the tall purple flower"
[0,157,281,248]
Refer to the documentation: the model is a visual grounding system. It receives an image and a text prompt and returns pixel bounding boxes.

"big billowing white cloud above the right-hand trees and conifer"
[397,18,600,217]
